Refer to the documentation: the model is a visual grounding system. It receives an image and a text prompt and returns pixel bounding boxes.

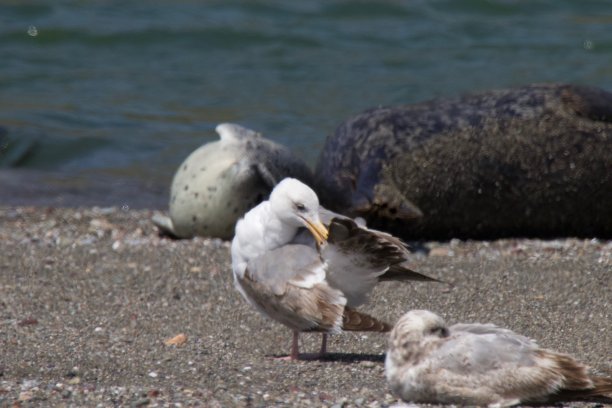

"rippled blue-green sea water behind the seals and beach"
[0,0,612,207]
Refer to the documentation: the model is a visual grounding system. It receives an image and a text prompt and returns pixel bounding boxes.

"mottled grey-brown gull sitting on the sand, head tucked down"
[385,310,612,407]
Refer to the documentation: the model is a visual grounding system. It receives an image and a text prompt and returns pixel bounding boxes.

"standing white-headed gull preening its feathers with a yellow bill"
[232,178,434,359]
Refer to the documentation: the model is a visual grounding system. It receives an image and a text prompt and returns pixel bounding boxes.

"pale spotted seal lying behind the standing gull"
[153,123,312,239]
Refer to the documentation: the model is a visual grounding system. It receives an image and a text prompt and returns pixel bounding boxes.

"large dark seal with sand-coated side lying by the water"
[315,84,612,239]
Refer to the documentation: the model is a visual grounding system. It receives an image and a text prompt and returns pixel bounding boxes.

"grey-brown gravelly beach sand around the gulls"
[0,207,612,407]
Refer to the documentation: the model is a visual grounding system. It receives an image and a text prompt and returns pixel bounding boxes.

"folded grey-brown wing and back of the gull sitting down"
[421,324,593,406]
